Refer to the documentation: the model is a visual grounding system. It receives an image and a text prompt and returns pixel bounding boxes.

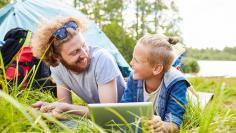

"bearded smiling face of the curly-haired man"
[60,33,90,73]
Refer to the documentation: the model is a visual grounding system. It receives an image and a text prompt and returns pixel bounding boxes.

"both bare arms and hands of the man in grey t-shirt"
[32,79,117,119]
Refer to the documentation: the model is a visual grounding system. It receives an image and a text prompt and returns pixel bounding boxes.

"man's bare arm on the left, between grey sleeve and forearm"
[57,85,72,104]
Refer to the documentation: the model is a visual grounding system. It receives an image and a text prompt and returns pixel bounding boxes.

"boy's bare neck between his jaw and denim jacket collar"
[145,75,163,93]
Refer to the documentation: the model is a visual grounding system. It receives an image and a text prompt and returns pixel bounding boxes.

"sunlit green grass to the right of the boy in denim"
[181,77,236,133]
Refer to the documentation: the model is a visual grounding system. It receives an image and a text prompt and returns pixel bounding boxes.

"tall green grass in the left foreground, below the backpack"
[0,50,97,133]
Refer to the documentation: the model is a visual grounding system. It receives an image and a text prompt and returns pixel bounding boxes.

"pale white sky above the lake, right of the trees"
[177,0,236,49]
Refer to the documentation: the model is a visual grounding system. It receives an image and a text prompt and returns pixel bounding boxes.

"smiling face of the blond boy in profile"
[130,44,154,80]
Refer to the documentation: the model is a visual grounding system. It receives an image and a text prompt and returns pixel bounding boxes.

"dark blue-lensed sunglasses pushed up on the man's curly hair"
[53,21,78,40]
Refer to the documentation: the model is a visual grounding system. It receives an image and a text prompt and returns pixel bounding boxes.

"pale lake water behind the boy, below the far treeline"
[197,60,236,77]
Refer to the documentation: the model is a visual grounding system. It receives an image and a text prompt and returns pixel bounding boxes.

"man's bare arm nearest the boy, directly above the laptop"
[98,79,118,103]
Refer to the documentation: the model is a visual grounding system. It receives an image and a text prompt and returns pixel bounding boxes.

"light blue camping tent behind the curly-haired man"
[0,0,129,76]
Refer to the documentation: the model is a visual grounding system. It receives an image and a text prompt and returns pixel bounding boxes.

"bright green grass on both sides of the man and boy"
[0,51,236,133]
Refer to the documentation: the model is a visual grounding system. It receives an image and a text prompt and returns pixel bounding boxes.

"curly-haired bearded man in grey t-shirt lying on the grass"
[32,17,125,116]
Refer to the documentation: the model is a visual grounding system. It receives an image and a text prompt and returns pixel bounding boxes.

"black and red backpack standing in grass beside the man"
[1,27,56,96]
